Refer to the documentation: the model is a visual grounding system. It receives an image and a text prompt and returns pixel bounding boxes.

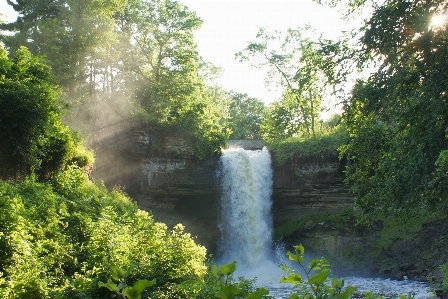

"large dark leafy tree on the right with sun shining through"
[336,0,448,213]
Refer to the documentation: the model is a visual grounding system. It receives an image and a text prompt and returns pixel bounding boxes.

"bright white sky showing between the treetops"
[0,0,362,110]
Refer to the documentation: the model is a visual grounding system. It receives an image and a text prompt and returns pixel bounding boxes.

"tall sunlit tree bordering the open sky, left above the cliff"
[128,0,202,123]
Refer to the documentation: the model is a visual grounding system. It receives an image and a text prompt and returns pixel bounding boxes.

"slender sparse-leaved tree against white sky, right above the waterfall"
[236,26,336,136]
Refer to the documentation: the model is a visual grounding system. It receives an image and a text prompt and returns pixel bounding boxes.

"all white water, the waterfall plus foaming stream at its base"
[217,148,432,299]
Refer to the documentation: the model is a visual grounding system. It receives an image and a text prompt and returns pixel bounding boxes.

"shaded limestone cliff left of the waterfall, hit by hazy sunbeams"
[90,122,219,251]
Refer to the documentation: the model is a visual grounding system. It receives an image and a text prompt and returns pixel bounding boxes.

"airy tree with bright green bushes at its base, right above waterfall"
[236,25,349,142]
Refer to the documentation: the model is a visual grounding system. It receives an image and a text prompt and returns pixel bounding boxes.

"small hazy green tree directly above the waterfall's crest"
[229,92,265,139]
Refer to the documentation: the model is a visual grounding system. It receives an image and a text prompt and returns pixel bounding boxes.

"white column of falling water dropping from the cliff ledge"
[218,148,273,272]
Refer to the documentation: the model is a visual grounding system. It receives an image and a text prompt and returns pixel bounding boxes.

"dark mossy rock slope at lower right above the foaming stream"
[283,221,448,284]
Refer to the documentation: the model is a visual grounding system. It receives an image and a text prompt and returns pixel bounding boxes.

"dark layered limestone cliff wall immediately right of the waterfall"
[273,152,353,224]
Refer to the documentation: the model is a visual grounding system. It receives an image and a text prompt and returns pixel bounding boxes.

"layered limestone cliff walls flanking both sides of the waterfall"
[91,122,352,252]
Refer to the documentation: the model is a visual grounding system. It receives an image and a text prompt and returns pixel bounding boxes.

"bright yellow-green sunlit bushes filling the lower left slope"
[0,166,206,299]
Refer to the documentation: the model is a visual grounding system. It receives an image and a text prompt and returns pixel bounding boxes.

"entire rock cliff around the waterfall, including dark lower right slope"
[90,122,448,280]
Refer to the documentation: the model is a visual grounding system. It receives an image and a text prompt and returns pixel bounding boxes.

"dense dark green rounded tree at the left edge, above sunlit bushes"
[0,47,93,179]
